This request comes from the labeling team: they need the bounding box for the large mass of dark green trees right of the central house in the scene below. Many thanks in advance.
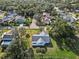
[49,17,79,54]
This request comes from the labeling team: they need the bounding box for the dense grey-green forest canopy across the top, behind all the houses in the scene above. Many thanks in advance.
[0,0,78,17]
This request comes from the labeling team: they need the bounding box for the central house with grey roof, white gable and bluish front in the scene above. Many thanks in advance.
[32,33,50,46]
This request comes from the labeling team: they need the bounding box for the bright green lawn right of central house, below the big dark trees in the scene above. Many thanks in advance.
[46,40,76,59]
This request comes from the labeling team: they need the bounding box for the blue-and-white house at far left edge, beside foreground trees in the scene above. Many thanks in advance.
[1,33,13,48]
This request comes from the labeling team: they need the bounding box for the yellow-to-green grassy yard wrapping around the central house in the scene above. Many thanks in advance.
[26,29,77,59]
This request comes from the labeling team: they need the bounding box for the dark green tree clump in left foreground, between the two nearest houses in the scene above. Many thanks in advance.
[4,29,33,59]
